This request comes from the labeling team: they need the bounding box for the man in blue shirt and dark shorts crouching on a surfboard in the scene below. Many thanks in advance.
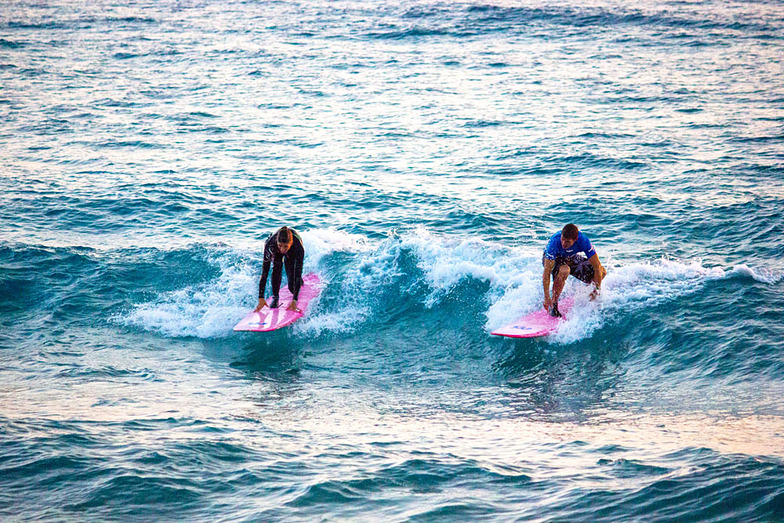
[542,223,607,317]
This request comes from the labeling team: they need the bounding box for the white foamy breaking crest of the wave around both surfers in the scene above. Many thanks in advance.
[114,228,782,343]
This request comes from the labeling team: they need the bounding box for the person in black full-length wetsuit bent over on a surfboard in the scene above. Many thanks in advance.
[255,227,305,312]
